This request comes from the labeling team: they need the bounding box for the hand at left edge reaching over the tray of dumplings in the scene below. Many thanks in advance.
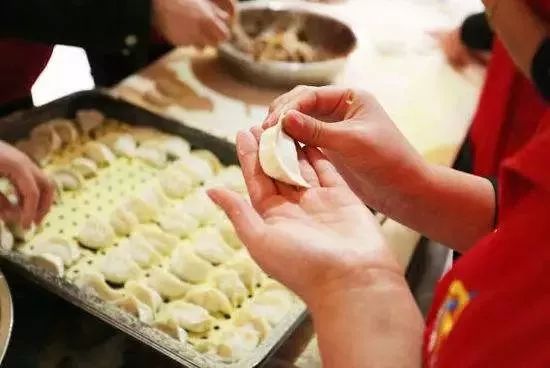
[0,142,54,229]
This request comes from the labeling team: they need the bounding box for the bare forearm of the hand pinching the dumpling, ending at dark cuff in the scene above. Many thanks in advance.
[380,165,496,252]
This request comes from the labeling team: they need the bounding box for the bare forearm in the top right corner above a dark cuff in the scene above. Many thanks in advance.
[483,0,548,78]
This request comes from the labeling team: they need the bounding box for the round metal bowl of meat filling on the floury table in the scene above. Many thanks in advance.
[219,2,357,87]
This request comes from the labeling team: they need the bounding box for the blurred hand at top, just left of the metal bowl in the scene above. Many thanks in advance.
[153,0,235,47]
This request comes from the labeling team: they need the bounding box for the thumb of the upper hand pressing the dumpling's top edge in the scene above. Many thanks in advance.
[283,110,350,151]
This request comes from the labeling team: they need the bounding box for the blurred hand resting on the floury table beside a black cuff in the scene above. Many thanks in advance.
[432,28,490,70]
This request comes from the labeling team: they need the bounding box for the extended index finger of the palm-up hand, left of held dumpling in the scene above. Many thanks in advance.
[237,131,277,208]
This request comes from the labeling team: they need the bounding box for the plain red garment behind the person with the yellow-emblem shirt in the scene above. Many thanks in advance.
[470,0,550,176]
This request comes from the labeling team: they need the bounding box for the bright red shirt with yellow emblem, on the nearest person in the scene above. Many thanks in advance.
[424,110,550,368]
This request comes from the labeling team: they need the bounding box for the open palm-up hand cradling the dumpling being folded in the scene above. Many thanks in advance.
[209,132,401,303]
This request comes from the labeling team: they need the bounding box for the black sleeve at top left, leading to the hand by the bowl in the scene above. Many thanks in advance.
[0,0,151,63]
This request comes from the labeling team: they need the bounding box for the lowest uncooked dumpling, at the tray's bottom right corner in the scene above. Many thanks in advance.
[217,325,260,359]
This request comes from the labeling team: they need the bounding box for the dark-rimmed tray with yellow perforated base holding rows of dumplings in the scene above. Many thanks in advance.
[0,91,305,367]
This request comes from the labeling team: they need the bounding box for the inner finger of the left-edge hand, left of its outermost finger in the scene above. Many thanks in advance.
[9,169,40,229]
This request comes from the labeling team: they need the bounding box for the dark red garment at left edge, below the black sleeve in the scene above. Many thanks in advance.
[0,39,52,105]
